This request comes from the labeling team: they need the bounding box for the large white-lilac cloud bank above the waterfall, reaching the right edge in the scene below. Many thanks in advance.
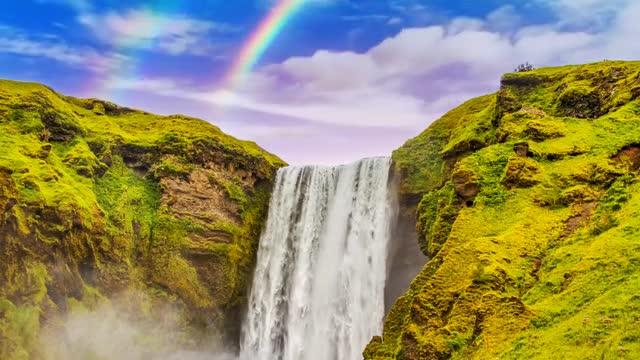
[95,4,640,162]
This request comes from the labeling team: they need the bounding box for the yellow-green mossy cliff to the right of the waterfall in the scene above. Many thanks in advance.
[364,62,640,359]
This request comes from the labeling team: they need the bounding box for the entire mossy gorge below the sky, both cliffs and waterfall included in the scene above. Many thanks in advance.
[0,61,640,360]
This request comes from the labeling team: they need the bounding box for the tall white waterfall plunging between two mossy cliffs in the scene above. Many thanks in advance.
[240,158,394,360]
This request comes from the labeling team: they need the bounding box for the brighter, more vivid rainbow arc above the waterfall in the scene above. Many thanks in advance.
[222,0,305,90]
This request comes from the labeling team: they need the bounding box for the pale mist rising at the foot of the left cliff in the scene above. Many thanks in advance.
[41,304,237,360]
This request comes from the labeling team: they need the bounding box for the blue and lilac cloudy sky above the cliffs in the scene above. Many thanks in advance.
[0,0,640,164]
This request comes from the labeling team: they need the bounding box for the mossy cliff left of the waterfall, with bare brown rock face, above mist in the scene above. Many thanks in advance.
[0,80,284,359]
